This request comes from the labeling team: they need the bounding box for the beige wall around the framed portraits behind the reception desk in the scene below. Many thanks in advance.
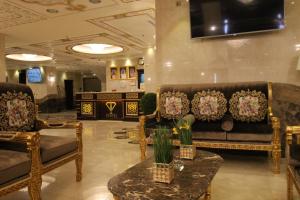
[106,59,142,92]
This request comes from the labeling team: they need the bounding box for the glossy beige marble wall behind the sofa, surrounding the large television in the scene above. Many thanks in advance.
[152,0,300,90]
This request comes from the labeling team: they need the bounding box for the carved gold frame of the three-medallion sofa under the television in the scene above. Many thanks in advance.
[139,83,281,174]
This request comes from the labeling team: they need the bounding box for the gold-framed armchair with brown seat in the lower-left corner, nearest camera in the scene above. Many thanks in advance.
[0,131,42,200]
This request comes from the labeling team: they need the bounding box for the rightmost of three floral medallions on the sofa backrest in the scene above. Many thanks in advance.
[229,90,268,122]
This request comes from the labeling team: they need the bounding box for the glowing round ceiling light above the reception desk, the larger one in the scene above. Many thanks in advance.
[72,43,124,54]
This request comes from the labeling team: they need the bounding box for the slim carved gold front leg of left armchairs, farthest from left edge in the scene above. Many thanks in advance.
[75,123,83,182]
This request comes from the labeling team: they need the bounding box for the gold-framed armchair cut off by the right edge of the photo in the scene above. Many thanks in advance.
[286,126,300,200]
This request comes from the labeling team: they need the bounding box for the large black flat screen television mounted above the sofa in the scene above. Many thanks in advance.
[189,0,285,38]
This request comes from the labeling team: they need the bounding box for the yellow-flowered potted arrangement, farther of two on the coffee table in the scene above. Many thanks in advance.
[173,114,196,159]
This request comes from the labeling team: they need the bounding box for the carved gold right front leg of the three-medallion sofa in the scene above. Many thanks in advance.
[272,117,281,174]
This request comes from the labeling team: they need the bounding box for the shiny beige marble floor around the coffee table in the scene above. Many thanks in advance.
[1,121,299,200]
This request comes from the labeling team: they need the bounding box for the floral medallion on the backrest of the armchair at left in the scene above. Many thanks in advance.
[0,92,35,131]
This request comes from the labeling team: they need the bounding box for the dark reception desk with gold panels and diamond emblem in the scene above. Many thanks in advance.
[76,92,144,121]
